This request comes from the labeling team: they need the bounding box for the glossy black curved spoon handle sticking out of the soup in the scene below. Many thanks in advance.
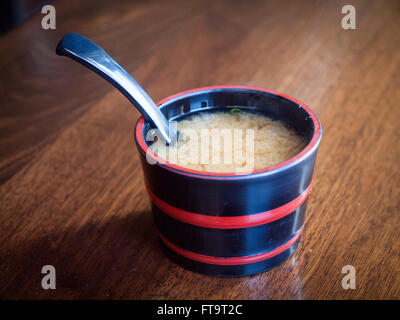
[56,33,176,143]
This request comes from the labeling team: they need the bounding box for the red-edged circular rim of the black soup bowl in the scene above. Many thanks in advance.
[135,85,322,180]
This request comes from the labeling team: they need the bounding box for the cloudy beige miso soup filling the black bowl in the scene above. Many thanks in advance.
[150,108,306,173]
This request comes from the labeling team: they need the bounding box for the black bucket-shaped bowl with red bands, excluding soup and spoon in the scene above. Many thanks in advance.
[135,86,321,276]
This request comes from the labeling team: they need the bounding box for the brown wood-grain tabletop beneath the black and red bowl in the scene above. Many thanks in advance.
[0,0,400,299]
